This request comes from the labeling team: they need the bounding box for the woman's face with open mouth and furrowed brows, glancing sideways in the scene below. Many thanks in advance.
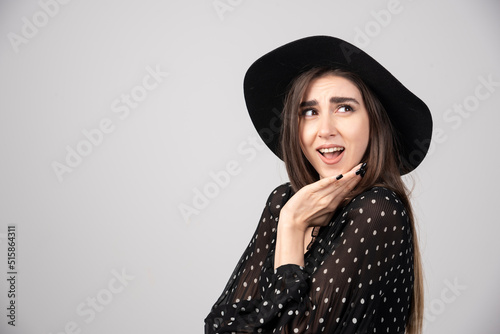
[299,75,370,178]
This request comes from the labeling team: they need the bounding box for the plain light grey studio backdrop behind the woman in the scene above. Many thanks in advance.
[0,0,500,334]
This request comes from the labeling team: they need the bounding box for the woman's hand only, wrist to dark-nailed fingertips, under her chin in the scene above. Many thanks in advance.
[280,164,361,232]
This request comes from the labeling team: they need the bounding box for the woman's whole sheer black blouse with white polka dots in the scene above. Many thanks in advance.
[205,183,413,334]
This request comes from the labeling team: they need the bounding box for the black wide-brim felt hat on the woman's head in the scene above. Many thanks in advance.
[243,36,432,173]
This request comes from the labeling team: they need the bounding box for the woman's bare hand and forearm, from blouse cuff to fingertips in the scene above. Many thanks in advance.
[274,164,364,269]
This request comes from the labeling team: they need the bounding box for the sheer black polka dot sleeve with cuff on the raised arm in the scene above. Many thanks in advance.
[205,184,309,333]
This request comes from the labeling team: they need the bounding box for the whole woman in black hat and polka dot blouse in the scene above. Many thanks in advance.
[205,36,432,334]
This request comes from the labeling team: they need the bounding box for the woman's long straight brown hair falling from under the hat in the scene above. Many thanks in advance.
[281,67,424,334]
